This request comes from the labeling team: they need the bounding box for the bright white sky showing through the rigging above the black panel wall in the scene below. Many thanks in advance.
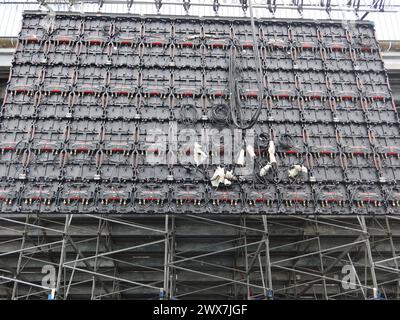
[0,0,400,41]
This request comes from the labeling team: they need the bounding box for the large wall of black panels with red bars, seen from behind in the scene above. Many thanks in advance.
[0,13,400,214]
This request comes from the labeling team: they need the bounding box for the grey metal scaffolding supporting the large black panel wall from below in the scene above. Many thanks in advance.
[0,214,400,300]
